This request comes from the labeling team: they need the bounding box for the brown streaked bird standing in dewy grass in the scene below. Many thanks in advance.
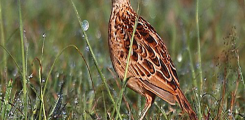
[108,0,197,120]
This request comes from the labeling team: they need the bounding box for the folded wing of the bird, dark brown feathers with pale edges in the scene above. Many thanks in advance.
[124,17,179,104]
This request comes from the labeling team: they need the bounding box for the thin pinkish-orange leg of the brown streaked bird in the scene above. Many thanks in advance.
[139,92,156,120]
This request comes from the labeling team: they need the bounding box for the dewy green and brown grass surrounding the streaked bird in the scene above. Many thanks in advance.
[0,0,245,120]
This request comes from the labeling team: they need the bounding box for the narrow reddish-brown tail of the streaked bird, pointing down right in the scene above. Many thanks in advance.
[176,89,198,120]
